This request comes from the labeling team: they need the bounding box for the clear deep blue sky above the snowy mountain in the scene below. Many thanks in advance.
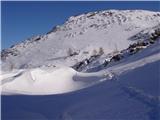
[1,1,159,49]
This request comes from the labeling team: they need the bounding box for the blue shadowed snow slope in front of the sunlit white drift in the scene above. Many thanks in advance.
[2,36,160,120]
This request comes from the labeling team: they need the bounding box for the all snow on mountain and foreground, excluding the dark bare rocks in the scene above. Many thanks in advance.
[0,10,160,120]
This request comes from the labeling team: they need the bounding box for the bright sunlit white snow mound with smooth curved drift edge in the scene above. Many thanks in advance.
[1,67,108,95]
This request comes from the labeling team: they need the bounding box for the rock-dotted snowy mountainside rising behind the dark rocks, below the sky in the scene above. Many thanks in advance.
[1,10,160,70]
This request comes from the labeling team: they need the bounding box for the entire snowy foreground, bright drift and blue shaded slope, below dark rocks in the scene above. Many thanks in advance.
[1,41,160,120]
